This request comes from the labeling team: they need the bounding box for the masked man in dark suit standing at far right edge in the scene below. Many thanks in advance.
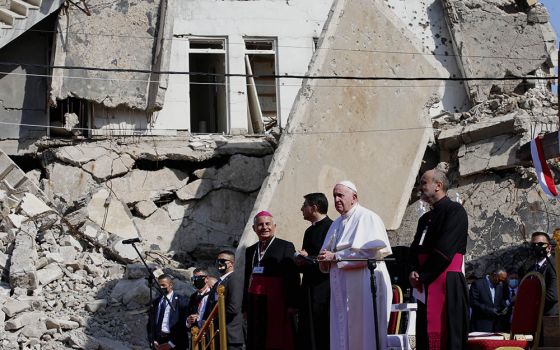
[528,232,558,316]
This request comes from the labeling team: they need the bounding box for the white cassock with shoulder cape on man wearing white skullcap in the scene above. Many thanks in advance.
[322,204,392,350]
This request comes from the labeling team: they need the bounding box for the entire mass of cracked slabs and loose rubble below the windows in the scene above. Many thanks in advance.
[0,136,274,349]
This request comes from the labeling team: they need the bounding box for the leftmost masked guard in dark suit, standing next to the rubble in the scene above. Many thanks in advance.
[148,274,187,350]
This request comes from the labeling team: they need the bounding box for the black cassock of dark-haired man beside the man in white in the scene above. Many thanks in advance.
[297,216,332,350]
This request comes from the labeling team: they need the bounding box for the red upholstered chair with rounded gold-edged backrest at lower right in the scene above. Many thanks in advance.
[468,272,545,350]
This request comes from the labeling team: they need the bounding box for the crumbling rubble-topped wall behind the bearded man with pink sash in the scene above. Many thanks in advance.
[389,89,560,277]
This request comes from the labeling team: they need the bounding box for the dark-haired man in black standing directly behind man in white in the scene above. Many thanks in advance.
[294,193,332,350]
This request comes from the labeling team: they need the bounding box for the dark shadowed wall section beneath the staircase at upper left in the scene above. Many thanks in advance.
[0,14,56,154]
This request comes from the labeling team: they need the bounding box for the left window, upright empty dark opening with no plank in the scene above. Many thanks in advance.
[186,35,231,134]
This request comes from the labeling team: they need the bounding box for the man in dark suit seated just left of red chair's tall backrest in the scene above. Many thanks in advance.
[469,269,507,332]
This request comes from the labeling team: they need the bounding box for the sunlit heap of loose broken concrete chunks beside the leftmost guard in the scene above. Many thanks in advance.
[0,190,199,350]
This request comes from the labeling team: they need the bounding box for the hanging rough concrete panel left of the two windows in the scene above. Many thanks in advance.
[50,0,168,111]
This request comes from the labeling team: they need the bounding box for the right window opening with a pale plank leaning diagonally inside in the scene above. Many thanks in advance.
[243,36,281,133]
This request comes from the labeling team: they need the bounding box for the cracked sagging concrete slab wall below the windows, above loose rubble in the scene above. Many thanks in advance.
[37,136,274,262]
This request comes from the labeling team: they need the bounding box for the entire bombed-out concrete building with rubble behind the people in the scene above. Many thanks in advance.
[0,0,560,349]
